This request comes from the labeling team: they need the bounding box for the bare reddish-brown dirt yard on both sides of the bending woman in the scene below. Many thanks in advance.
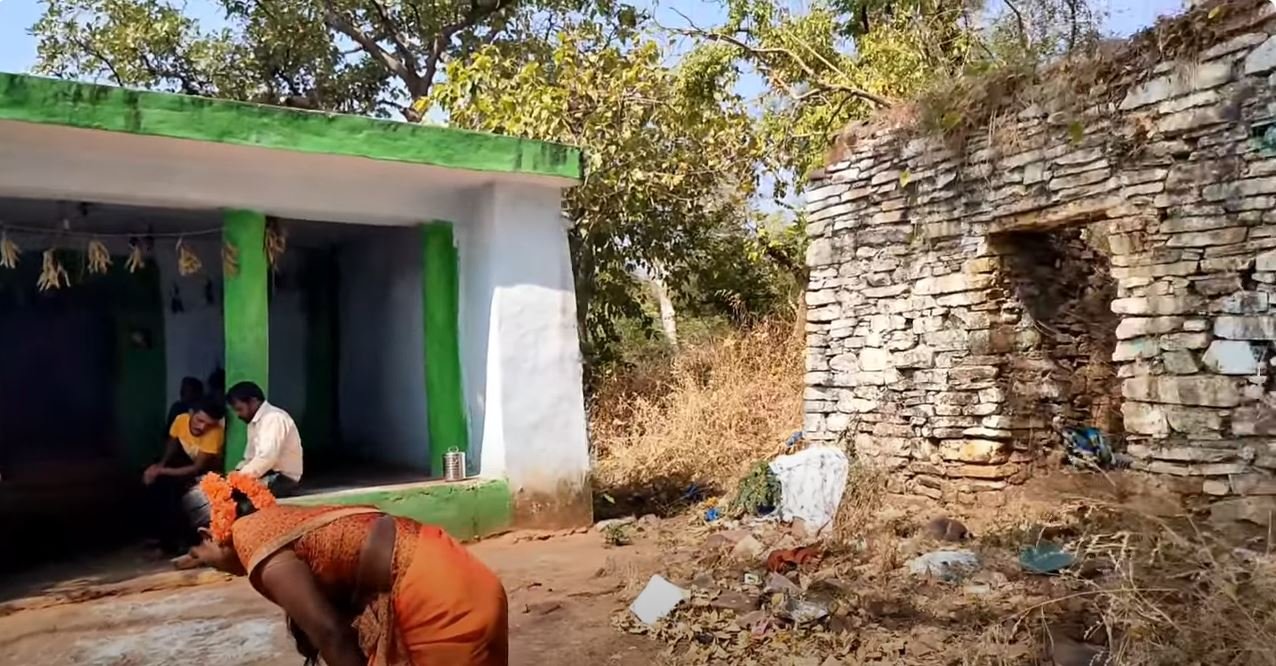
[0,532,662,666]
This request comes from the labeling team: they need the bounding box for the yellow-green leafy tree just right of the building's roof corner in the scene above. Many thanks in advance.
[430,17,760,359]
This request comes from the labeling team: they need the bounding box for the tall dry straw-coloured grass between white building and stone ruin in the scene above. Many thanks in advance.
[590,315,804,495]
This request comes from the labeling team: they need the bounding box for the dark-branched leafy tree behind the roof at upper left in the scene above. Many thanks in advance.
[31,0,584,120]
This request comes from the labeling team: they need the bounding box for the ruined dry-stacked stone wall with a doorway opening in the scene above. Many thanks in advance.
[805,3,1276,505]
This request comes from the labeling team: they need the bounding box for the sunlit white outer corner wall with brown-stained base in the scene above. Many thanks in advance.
[459,185,592,524]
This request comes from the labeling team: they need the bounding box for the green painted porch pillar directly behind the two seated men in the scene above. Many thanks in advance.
[222,211,271,471]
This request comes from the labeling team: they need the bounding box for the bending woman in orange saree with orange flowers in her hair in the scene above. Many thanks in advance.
[188,473,509,666]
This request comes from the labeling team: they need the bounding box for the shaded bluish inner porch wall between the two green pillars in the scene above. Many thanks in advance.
[338,227,429,471]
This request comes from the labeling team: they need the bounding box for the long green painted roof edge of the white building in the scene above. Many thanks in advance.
[0,73,583,180]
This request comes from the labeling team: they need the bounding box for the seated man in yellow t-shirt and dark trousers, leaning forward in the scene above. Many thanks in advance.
[142,399,226,554]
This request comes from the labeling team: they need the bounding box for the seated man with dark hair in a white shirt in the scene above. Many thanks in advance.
[226,381,301,496]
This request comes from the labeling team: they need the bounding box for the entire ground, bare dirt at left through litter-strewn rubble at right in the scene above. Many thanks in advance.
[0,473,1276,666]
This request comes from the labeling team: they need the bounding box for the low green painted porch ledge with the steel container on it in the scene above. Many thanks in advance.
[283,478,514,541]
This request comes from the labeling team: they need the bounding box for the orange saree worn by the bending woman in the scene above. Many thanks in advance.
[232,505,509,666]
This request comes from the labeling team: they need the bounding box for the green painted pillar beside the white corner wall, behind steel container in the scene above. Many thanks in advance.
[421,222,470,476]
